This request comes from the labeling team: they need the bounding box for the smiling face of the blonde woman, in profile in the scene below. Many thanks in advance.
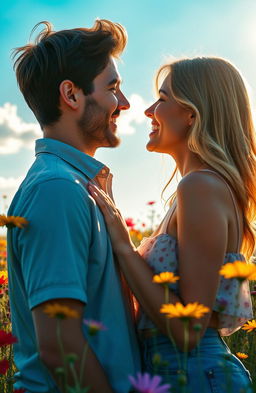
[145,76,193,154]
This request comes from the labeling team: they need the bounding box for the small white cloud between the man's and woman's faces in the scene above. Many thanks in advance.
[117,94,149,134]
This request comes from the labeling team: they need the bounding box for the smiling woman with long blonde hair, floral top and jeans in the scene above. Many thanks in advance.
[90,58,256,393]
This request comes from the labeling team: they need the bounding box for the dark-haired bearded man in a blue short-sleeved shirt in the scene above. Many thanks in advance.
[8,20,140,393]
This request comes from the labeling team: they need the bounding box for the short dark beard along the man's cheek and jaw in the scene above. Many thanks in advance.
[77,97,120,147]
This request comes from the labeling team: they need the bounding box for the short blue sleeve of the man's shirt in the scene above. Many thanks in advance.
[18,179,91,309]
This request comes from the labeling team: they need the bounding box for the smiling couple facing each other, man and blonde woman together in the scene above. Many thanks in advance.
[8,20,256,393]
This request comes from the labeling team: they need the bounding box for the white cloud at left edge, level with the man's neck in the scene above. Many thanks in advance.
[0,102,42,154]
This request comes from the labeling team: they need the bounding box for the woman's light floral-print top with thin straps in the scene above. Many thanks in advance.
[138,170,253,336]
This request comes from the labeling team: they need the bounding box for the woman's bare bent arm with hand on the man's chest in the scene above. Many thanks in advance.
[91,173,227,349]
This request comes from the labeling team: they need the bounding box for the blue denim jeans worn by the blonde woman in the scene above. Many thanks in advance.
[141,328,252,393]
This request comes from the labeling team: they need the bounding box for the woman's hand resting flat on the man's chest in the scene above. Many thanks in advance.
[88,183,135,255]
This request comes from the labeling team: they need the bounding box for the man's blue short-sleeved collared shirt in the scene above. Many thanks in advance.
[7,138,140,393]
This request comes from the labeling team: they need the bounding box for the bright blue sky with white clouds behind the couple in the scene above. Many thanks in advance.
[0,0,256,230]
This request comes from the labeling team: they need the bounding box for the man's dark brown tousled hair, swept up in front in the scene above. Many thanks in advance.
[13,19,127,127]
